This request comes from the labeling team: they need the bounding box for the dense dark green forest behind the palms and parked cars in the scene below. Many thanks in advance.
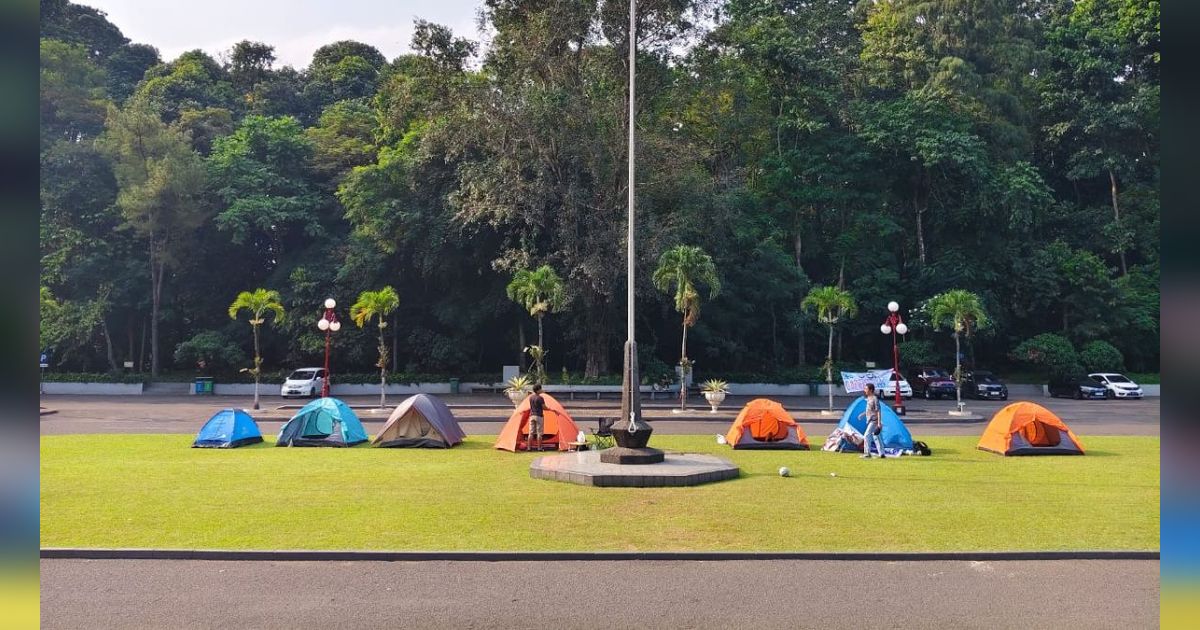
[41,0,1159,379]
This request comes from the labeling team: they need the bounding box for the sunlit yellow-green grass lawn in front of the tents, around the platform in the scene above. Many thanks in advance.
[41,428,1159,551]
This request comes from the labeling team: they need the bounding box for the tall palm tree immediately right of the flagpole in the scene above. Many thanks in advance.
[652,245,721,409]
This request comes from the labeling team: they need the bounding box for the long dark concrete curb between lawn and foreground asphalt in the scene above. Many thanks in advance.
[41,547,1159,562]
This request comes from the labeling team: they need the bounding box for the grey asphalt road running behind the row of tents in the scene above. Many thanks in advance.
[41,395,1159,436]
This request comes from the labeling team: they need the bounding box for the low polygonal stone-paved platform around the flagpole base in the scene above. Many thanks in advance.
[529,451,738,487]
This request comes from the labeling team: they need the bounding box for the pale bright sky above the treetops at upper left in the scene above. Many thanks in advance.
[78,0,482,68]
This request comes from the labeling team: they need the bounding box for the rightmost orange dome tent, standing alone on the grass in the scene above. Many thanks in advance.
[979,402,1084,455]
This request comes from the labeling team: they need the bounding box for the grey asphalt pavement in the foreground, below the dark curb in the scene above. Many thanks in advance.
[41,560,1159,630]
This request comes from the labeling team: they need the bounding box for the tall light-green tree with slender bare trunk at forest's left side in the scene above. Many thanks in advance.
[98,102,209,377]
